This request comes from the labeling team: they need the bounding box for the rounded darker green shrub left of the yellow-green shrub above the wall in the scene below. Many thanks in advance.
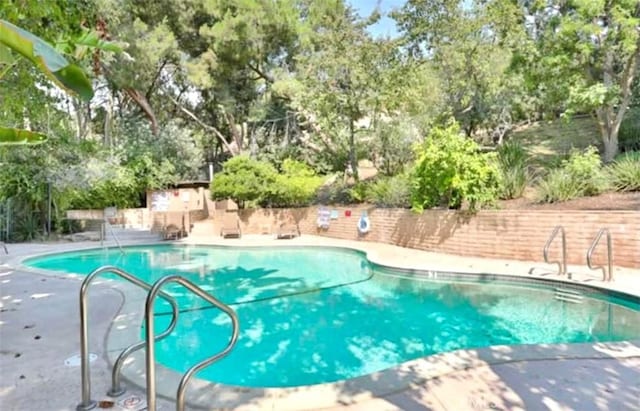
[211,156,278,208]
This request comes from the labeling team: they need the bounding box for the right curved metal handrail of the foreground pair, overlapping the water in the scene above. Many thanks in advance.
[145,275,239,411]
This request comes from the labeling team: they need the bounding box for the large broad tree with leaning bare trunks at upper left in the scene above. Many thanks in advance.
[110,0,299,161]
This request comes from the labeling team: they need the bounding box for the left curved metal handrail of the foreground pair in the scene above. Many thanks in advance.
[76,266,178,411]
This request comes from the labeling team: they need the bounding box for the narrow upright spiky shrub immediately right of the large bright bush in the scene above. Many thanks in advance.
[498,141,530,199]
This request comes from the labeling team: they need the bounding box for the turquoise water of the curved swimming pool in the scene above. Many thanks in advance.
[25,245,640,387]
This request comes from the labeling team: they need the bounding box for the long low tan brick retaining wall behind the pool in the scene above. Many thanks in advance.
[238,206,640,268]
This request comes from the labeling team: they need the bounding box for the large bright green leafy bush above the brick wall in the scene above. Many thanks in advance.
[411,123,499,211]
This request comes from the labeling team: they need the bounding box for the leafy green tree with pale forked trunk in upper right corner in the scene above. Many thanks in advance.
[519,0,640,162]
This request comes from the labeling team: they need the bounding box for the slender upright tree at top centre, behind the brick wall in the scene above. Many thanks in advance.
[274,0,396,179]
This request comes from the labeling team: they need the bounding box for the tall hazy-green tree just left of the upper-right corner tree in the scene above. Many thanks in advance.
[394,0,524,137]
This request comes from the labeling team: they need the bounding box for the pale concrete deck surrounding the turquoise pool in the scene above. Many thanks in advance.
[0,236,640,411]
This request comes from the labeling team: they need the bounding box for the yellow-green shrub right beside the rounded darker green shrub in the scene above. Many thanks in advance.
[263,159,322,207]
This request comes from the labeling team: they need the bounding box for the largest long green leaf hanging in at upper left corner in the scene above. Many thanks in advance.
[0,20,93,100]
